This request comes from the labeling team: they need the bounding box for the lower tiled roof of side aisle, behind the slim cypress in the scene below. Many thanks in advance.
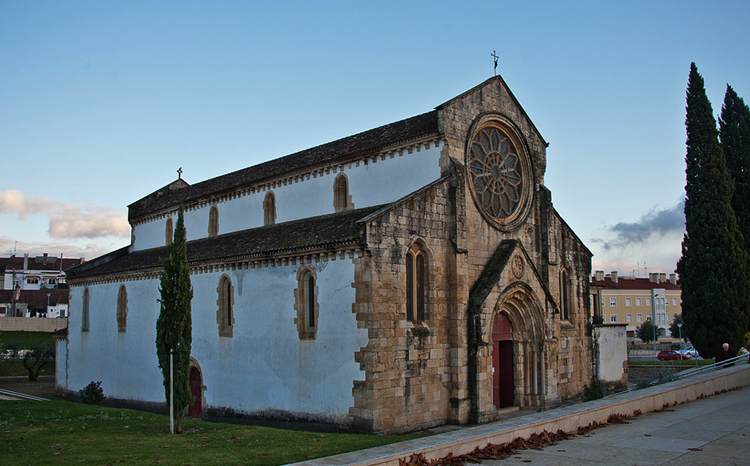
[67,206,382,280]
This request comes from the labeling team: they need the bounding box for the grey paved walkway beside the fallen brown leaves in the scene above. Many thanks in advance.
[482,387,750,466]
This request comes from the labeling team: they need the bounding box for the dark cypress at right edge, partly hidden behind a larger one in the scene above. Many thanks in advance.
[719,85,750,251]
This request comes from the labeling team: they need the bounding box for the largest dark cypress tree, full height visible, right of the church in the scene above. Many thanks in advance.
[677,63,748,357]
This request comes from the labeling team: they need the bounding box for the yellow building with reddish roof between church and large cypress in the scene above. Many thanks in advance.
[590,270,682,338]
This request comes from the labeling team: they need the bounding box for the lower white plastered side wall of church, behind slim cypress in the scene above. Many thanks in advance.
[68,259,367,422]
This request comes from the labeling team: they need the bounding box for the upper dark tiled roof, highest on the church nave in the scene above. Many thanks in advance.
[128,110,439,221]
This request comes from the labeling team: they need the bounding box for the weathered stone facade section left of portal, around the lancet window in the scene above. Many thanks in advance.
[350,180,455,432]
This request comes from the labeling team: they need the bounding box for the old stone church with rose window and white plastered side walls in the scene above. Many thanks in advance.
[63,76,592,433]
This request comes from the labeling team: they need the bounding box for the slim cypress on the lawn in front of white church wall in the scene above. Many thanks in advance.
[156,204,193,432]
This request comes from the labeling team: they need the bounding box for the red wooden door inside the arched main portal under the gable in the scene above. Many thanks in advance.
[492,314,515,409]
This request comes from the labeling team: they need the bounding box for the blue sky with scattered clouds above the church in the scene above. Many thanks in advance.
[0,0,750,276]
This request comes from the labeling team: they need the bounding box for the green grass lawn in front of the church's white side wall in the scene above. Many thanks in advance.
[0,401,417,466]
